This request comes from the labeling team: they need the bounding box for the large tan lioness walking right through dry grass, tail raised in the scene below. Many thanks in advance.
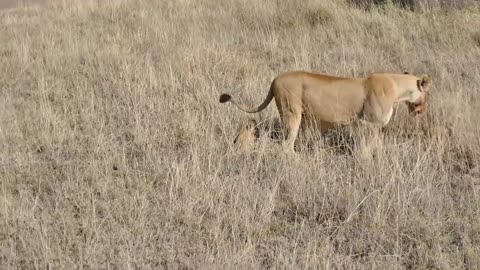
[220,71,432,151]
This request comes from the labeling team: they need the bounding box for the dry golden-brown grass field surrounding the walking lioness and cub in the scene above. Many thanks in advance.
[0,0,480,269]
